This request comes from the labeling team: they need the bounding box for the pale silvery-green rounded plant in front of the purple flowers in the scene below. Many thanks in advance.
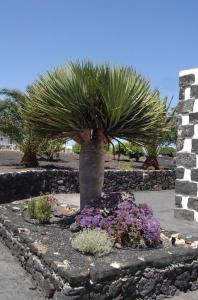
[71,229,113,256]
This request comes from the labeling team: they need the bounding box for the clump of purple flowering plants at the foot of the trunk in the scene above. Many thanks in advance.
[76,193,160,249]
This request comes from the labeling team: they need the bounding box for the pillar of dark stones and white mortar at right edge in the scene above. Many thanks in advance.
[175,68,198,222]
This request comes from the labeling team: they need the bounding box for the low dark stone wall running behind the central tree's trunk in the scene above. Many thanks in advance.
[0,169,175,203]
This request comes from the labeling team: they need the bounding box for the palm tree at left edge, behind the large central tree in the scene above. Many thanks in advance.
[0,89,39,167]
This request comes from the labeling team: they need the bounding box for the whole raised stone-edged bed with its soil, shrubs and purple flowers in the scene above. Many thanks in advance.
[0,193,198,300]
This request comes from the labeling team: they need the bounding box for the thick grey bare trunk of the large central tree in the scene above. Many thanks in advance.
[79,140,104,209]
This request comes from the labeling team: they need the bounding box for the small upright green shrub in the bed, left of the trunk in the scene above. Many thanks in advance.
[28,196,51,224]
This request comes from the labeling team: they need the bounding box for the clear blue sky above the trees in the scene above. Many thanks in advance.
[0,0,198,105]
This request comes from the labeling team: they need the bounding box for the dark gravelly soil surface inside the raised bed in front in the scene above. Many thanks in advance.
[0,200,175,268]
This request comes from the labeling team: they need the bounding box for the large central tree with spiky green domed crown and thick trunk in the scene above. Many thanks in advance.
[24,62,170,209]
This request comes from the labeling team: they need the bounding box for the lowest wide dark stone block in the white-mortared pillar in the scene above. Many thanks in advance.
[175,180,197,196]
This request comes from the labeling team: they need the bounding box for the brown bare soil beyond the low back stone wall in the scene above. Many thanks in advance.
[0,150,175,173]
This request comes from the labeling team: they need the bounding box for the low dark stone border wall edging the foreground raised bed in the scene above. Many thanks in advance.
[0,204,198,300]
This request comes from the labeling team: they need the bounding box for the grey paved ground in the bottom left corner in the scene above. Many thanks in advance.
[0,241,44,300]
